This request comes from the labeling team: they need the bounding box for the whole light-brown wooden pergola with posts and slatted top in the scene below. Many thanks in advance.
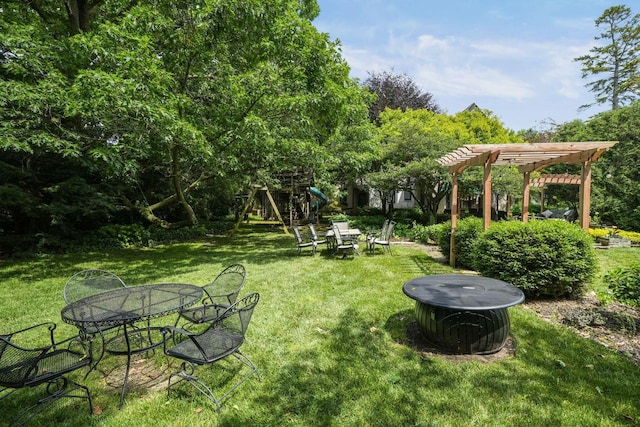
[438,141,617,266]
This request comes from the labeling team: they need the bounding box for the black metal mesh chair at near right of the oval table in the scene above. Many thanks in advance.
[163,292,260,410]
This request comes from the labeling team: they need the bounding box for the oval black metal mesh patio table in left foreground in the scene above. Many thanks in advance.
[61,283,204,407]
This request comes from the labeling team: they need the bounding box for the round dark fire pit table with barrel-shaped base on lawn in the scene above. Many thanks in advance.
[402,274,524,354]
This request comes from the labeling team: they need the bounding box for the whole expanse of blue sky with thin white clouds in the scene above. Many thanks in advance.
[314,0,624,130]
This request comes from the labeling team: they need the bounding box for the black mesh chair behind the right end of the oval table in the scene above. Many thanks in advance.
[176,264,247,327]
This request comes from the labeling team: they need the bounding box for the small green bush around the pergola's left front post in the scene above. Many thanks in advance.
[438,216,484,269]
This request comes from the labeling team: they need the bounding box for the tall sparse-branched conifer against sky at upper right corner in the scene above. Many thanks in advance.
[574,6,640,110]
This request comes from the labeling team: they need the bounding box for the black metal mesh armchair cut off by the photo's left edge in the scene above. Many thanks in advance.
[0,322,93,425]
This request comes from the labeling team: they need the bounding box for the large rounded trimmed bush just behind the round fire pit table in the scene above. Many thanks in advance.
[474,221,596,298]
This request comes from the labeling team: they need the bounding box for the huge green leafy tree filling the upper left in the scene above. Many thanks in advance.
[0,0,370,234]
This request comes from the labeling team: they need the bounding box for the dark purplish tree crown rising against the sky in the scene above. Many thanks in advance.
[364,71,441,125]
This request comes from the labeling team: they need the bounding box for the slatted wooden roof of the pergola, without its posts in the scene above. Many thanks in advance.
[438,141,617,173]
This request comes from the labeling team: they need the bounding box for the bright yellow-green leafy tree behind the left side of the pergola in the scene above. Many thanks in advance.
[367,109,521,221]
